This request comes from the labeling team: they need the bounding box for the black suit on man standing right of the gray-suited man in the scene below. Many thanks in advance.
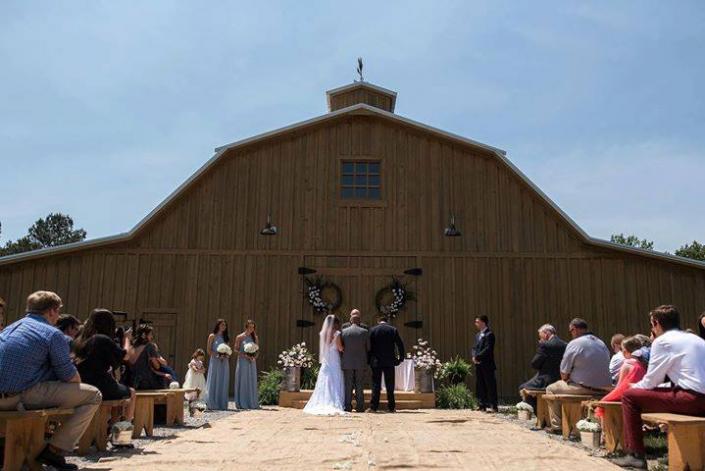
[369,322,404,411]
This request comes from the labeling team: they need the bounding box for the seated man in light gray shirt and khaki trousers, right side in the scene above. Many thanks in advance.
[546,318,612,433]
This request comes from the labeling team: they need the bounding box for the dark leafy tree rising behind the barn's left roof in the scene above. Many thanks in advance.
[0,213,86,256]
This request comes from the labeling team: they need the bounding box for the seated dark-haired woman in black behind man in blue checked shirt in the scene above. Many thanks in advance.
[74,309,135,421]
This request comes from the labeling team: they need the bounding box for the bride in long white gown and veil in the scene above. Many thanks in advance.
[304,314,345,415]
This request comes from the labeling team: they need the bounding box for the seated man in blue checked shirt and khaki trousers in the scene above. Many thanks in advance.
[0,291,101,470]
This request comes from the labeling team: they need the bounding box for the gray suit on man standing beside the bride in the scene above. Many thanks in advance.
[341,324,370,412]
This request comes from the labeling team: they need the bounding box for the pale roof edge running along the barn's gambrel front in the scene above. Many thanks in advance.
[0,100,705,269]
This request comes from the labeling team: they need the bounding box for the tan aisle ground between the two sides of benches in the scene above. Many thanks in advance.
[87,408,619,471]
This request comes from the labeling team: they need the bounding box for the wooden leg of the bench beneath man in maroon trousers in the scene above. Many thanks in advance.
[668,423,705,471]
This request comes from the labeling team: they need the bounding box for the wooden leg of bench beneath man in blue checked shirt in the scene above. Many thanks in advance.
[3,417,47,471]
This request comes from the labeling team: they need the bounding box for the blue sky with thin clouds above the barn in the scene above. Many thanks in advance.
[0,0,705,251]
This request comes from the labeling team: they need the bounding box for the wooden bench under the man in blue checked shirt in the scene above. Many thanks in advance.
[0,409,73,471]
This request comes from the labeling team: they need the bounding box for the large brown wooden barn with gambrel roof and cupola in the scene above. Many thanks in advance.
[0,82,705,396]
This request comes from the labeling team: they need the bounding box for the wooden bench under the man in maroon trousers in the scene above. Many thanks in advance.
[641,412,705,471]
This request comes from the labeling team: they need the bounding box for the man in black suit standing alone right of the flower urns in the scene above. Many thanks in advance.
[472,315,498,412]
